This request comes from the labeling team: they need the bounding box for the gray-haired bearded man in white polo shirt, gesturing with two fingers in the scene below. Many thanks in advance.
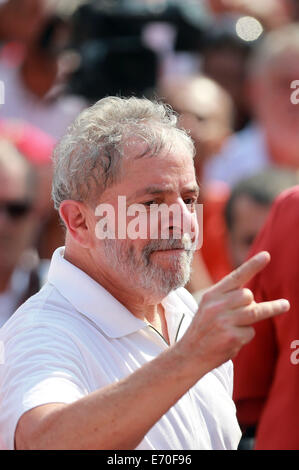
[0,97,289,450]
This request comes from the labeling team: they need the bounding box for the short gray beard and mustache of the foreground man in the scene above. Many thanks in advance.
[104,239,194,297]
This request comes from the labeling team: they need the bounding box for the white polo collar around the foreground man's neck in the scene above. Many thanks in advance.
[48,247,191,338]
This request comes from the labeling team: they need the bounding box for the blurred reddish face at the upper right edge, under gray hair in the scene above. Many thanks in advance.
[251,51,299,168]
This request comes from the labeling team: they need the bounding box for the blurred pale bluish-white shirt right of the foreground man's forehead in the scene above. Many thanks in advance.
[203,125,270,186]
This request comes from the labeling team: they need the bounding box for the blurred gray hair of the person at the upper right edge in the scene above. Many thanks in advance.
[248,23,299,76]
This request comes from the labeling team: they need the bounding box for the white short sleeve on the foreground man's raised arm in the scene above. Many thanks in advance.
[0,326,89,450]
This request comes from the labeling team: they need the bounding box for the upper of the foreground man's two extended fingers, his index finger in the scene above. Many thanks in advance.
[209,251,270,293]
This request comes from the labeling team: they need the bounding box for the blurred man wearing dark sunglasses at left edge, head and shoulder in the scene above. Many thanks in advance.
[0,138,40,326]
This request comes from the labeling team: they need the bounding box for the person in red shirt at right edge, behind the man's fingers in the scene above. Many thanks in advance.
[234,186,299,450]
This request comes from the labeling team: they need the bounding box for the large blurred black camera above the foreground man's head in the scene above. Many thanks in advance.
[69,0,206,101]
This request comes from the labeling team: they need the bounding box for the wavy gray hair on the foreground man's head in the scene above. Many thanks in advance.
[52,97,194,209]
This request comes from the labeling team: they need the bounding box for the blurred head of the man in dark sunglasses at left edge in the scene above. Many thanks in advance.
[0,141,36,272]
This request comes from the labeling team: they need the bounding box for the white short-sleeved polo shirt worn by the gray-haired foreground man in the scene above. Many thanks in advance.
[0,247,241,450]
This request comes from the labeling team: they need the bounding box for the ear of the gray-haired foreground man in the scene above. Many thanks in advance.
[59,199,91,248]
